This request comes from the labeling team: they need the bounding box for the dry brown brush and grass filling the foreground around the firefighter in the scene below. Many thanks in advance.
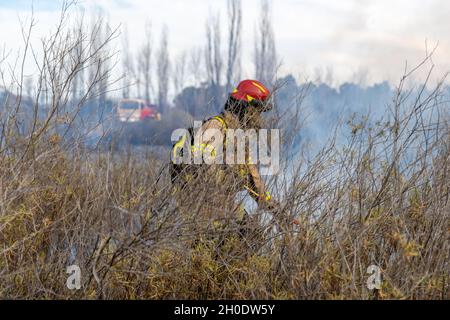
[0,2,450,299]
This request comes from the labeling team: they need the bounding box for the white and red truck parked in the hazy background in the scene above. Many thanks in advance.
[117,99,161,122]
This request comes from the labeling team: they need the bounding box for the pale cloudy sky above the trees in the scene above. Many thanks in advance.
[0,0,450,86]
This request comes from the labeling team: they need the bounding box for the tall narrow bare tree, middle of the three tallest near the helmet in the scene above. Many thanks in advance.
[225,0,242,93]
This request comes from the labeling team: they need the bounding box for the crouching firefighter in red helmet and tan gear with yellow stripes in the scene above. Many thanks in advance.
[172,80,277,242]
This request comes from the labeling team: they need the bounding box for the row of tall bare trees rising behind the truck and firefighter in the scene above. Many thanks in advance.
[122,0,278,113]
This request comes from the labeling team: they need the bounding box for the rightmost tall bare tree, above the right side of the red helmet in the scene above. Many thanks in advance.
[254,0,278,85]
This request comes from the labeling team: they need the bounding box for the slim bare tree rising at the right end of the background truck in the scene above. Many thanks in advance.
[156,26,170,112]
